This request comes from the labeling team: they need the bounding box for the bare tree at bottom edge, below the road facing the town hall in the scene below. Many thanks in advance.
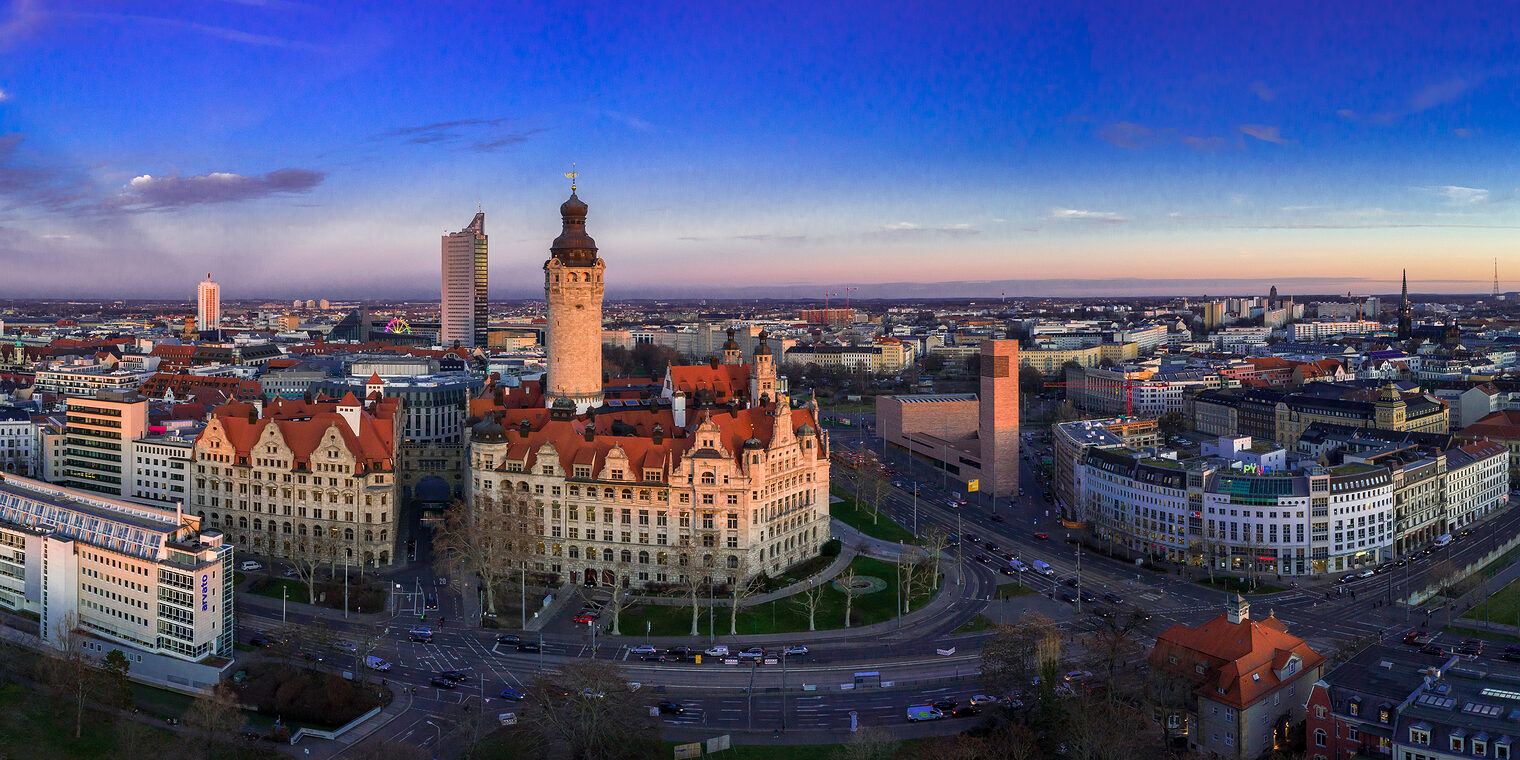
[518,660,660,760]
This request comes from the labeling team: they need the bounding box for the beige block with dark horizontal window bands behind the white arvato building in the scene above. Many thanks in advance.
[62,389,147,497]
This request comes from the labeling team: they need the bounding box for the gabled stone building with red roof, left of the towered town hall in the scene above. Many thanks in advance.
[185,394,400,567]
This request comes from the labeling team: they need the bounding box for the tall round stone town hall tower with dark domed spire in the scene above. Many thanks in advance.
[544,172,606,412]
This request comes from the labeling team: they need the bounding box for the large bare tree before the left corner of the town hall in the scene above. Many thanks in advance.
[433,483,543,616]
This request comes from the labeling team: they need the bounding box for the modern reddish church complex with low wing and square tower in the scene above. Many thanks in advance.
[876,340,1020,497]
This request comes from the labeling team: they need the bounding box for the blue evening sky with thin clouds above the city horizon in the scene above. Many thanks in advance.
[0,0,1520,298]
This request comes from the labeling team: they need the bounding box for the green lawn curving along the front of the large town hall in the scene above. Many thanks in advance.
[617,556,932,637]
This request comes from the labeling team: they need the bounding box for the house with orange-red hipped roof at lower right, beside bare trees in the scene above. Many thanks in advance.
[1149,596,1325,760]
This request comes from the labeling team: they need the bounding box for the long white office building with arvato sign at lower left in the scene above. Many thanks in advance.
[0,476,236,689]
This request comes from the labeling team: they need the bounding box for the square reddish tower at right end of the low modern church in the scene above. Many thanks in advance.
[976,340,1018,499]
